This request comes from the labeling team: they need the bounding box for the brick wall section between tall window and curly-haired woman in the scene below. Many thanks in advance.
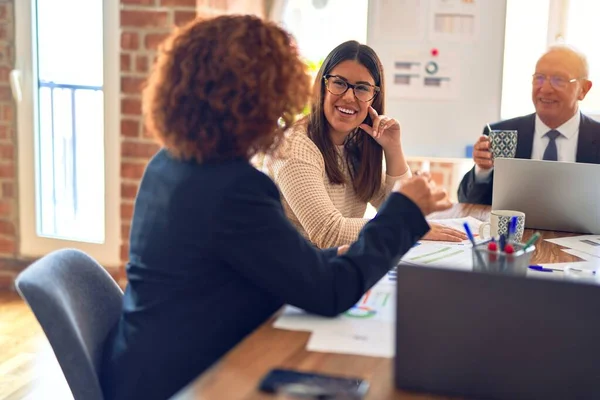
[120,0,263,278]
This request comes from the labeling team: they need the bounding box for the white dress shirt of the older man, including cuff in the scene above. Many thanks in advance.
[475,110,581,183]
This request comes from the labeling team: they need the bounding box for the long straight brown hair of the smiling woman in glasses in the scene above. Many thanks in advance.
[307,40,385,202]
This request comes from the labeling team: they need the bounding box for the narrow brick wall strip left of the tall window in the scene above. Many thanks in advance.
[0,0,18,288]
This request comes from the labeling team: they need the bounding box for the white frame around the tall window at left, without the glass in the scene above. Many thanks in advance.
[11,0,121,267]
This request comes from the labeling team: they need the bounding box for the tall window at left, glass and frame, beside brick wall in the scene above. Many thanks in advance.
[13,0,120,266]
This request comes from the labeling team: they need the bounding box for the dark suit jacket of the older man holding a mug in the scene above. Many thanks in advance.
[458,114,600,205]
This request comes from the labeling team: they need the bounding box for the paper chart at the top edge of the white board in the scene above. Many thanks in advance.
[428,0,481,43]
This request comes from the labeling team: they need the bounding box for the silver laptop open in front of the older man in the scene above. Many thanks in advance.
[492,158,600,234]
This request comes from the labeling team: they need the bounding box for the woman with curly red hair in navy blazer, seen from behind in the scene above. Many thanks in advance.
[101,15,449,400]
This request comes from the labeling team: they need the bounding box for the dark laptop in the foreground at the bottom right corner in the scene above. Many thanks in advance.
[394,264,600,400]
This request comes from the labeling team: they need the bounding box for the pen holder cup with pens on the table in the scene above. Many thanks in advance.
[472,240,535,276]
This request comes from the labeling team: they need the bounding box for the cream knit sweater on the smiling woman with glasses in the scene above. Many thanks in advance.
[262,124,411,248]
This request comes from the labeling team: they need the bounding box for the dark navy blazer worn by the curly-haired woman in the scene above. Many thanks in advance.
[101,150,429,400]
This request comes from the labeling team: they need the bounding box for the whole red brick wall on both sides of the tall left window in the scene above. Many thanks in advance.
[0,0,272,289]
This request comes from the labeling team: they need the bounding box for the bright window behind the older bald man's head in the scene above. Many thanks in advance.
[501,0,600,119]
